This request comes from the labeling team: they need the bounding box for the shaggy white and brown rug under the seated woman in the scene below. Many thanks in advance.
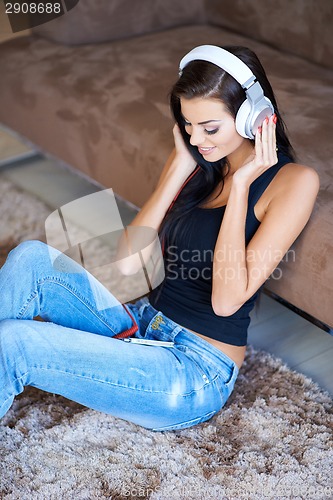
[0,180,333,500]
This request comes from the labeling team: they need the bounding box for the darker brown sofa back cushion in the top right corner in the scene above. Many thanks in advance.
[205,0,333,68]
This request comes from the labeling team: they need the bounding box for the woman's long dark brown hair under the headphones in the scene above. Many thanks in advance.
[160,46,295,244]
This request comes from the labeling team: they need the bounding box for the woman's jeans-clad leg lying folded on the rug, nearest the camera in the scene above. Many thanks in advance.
[0,320,222,430]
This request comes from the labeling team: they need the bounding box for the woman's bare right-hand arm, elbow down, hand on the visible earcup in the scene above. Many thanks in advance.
[212,115,319,316]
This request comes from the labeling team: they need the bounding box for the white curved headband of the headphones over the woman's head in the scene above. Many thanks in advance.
[179,45,256,90]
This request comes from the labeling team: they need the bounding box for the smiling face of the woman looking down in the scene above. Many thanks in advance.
[180,97,249,162]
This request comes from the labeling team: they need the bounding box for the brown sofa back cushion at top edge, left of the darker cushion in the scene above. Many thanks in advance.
[32,0,205,45]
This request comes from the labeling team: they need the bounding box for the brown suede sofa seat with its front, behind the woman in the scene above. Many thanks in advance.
[0,25,333,327]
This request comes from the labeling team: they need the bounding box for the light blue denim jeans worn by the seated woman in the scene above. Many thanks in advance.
[0,241,238,431]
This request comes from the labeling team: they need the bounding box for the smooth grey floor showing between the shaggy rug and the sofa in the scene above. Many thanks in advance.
[0,130,333,395]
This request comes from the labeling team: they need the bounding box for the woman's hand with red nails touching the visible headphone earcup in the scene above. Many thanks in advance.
[233,114,278,186]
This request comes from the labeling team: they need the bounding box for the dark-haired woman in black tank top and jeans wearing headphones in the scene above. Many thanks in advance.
[0,46,319,430]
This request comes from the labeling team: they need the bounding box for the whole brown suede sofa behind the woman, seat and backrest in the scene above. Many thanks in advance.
[0,0,333,327]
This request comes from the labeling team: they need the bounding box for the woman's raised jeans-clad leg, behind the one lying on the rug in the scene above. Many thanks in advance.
[0,241,132,336]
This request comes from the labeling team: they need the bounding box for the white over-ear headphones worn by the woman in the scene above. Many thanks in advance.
[179,45,274,139]
